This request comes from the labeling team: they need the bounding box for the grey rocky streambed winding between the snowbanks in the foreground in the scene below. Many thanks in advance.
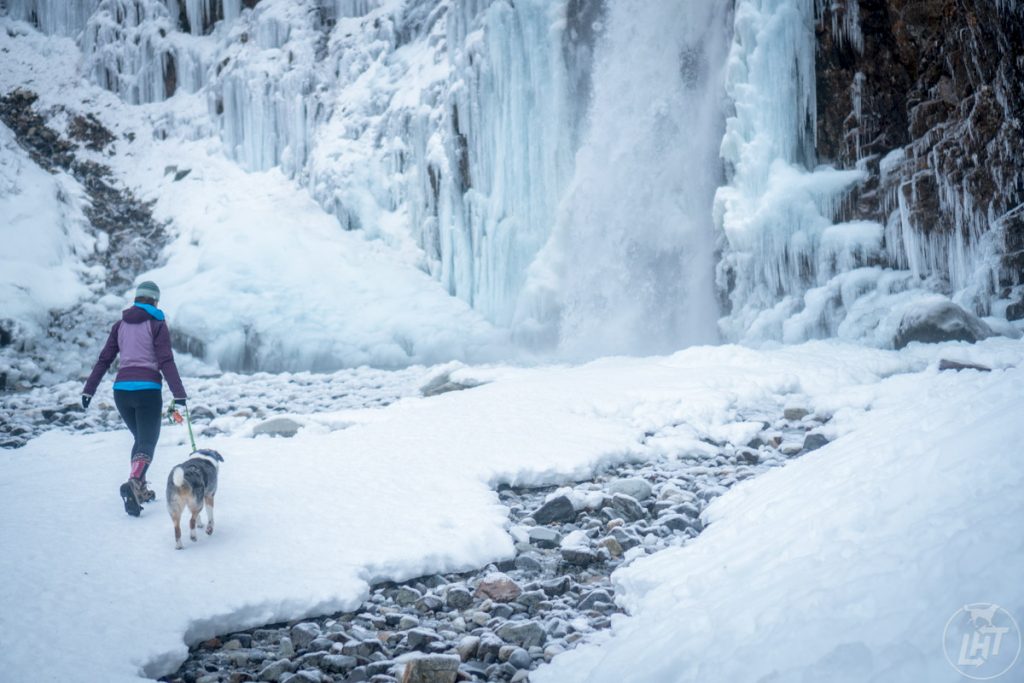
[161,408,827,683]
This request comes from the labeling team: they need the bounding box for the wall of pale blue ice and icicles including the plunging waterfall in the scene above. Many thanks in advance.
[6,0,1017,368]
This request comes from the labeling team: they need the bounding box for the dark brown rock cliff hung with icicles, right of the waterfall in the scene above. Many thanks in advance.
[816,0,1024,319]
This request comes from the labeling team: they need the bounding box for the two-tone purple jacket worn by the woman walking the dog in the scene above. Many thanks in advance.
[82,306,187,398]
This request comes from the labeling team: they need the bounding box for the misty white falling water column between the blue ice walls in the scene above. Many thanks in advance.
[517,0,731,356]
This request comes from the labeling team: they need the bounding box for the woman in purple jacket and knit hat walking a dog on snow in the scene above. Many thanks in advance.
[82,281,186,517]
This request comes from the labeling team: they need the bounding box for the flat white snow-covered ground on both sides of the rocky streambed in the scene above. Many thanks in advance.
[0,339,1024,681]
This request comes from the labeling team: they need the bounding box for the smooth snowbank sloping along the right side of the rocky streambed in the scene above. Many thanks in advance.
[531,342,1024,683]
